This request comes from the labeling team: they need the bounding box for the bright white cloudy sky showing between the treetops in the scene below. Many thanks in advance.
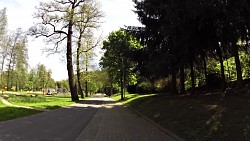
[0,0,141,80]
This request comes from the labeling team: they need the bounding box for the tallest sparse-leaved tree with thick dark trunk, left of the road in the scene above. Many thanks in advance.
[30,0,92,101]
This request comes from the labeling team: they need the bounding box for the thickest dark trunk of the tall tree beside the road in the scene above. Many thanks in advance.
[66,4,79,101]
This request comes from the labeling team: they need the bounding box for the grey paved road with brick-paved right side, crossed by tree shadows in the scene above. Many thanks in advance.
[0,95,182,141]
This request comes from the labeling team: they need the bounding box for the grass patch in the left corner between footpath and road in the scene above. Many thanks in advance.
[0,101,41,121]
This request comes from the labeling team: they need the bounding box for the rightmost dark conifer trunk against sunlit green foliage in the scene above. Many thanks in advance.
[232,44,242,86]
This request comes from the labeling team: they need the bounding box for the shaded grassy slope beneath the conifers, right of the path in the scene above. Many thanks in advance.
[114,94,250,141]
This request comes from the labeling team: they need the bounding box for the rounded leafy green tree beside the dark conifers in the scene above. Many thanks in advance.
[101,30,141,100]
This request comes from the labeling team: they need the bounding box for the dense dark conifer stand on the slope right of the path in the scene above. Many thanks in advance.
[103,0,250,95]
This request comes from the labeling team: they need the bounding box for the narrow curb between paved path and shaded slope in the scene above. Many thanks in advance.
[119,102,185,141]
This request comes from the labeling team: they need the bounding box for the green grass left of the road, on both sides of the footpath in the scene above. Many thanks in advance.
[0,94,83,121]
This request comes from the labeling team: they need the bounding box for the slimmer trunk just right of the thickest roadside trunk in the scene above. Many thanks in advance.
[76,34,84,98]
